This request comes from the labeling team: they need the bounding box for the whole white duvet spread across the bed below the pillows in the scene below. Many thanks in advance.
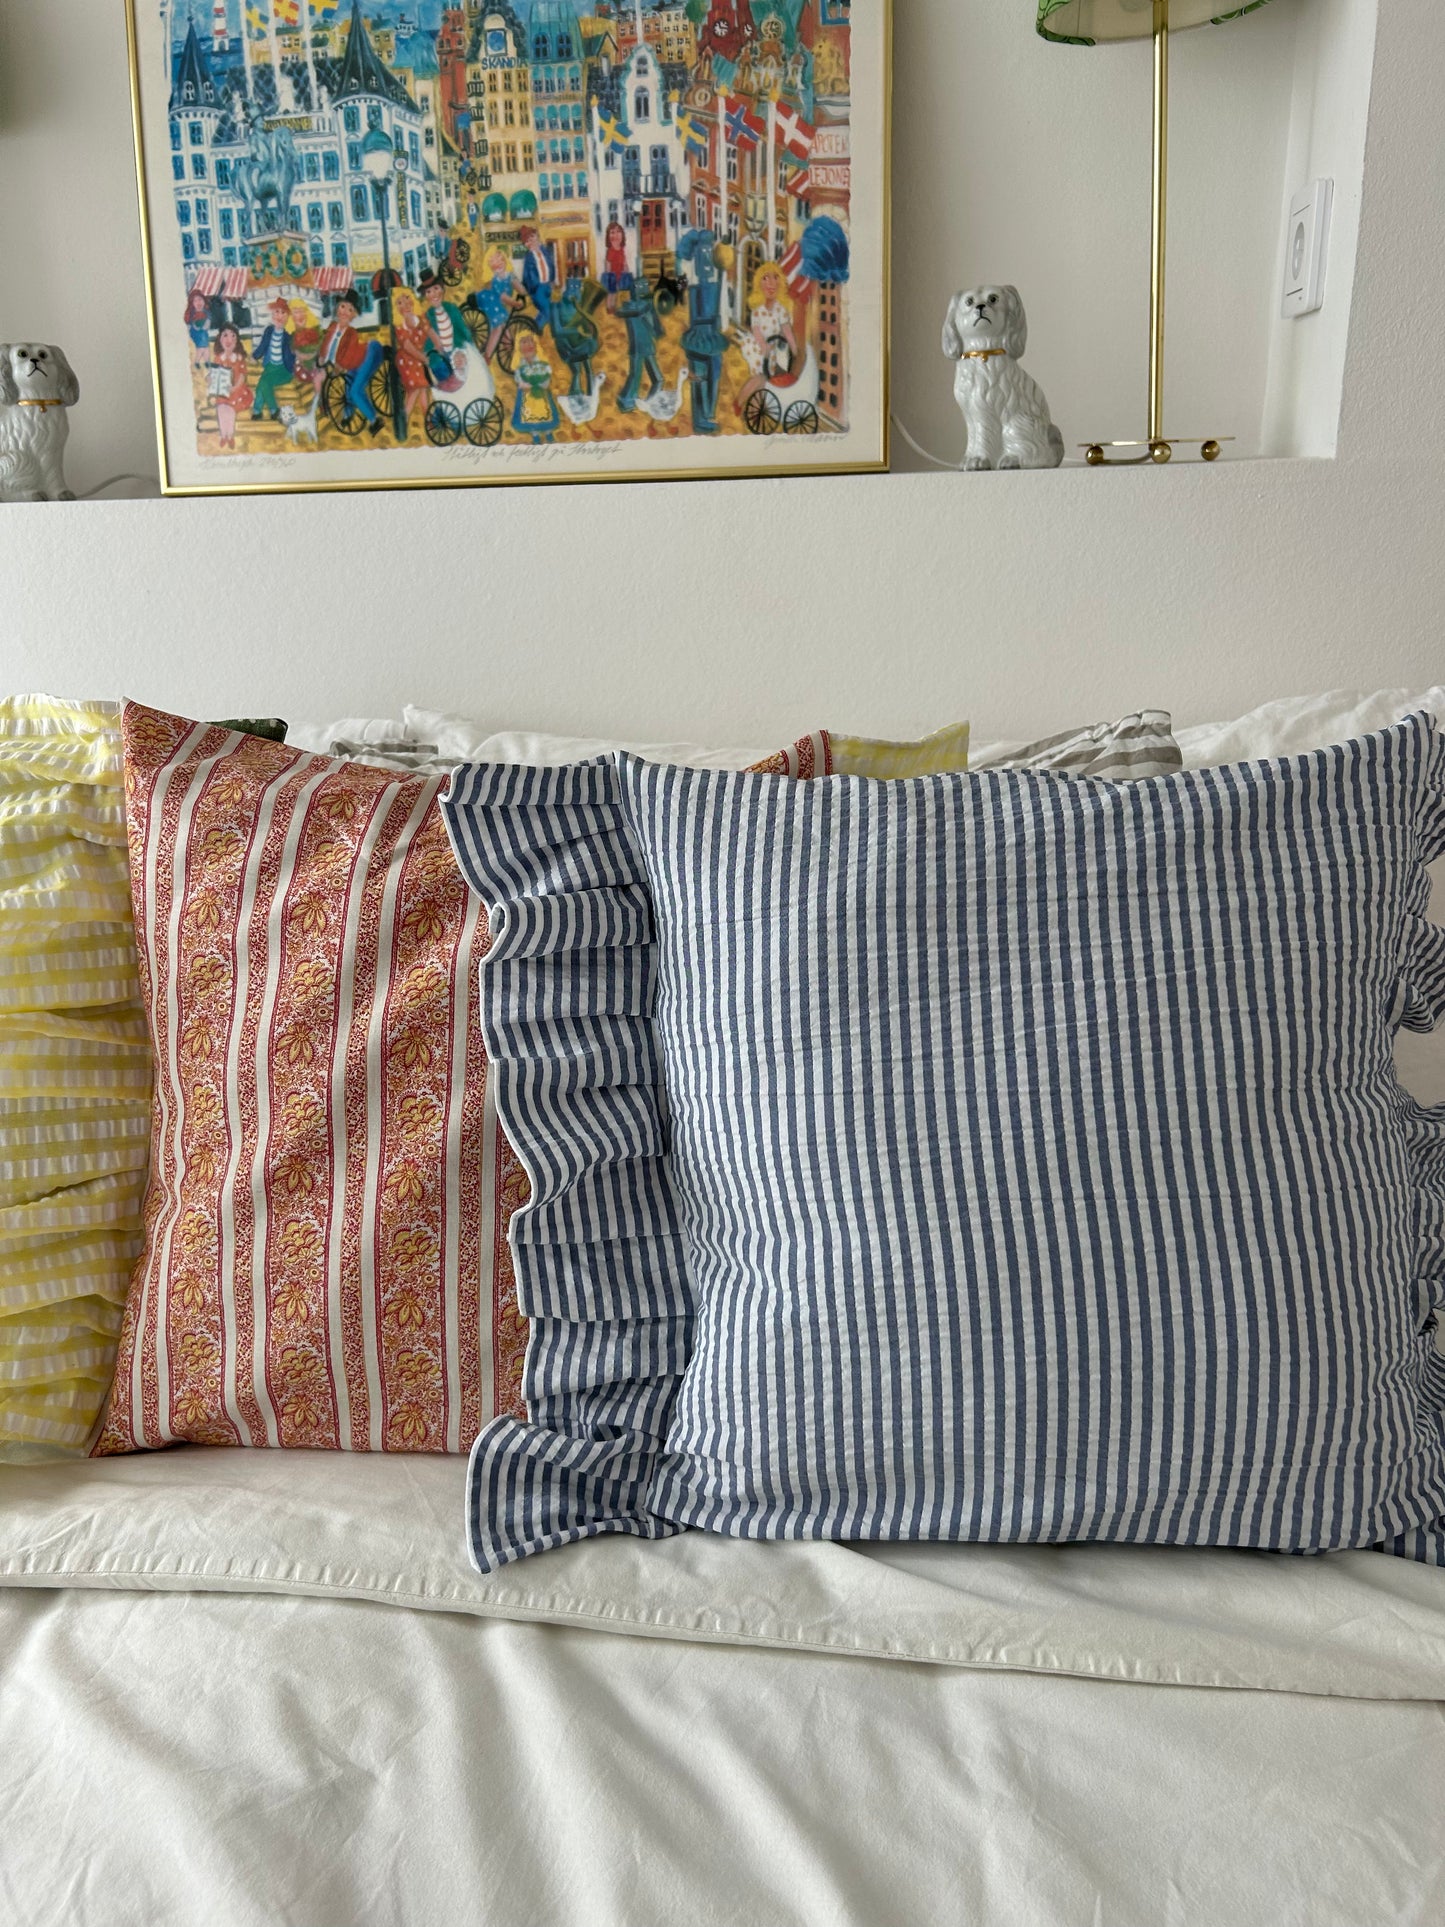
[0,1449,1445,1927]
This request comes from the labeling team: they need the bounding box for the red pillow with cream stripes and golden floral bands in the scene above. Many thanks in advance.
[94,705,526,1455]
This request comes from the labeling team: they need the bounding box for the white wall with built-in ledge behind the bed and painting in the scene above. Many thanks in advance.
[0,0,1445,740]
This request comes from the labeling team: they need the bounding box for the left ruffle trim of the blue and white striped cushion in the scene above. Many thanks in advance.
[443,759,694,1572]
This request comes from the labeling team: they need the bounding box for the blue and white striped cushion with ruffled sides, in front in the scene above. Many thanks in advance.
[449,719,1445,1569]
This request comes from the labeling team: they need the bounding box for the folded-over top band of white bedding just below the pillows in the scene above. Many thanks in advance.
[0,1449,1445,1700]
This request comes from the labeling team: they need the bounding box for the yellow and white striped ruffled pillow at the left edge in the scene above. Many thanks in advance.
[0,696,150,1459]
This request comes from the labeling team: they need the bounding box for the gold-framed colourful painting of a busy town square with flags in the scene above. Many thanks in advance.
[127,0,890,495]
